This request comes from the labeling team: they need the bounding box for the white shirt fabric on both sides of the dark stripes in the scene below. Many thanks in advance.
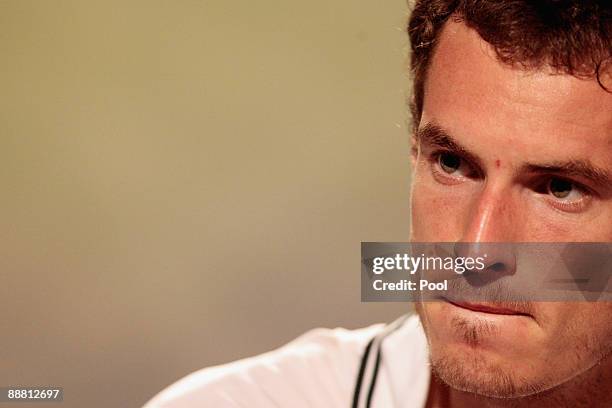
[144,316,430,408]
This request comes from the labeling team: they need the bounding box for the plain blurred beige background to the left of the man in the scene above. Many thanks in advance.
[0,0,409,408]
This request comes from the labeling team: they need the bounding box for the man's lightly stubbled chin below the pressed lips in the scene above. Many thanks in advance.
[417,302,557,398]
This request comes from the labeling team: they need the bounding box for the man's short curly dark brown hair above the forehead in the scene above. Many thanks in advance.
[408,0,612,129]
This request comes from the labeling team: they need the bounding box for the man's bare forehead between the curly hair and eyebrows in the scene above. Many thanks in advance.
[422,22,612,164]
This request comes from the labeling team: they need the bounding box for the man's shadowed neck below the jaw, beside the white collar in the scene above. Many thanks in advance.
[426,356,612,408]
